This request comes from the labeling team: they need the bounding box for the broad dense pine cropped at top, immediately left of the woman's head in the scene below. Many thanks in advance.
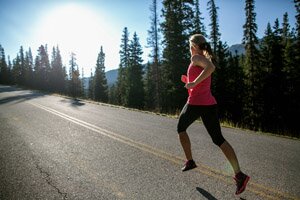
[161,0,193,112]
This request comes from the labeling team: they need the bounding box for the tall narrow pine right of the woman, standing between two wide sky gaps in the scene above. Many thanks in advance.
[243,0,263,130]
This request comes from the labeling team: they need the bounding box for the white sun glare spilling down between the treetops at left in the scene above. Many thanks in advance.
[34,4,116,72]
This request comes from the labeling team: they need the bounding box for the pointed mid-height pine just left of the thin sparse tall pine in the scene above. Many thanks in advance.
[125,32,144,109]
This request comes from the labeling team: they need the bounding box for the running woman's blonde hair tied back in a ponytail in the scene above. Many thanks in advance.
[189,34,214,61]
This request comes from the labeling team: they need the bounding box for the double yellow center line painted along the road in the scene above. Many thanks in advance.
[28,102,300,200]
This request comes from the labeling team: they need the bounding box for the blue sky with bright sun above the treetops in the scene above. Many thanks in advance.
[0,0,296,76]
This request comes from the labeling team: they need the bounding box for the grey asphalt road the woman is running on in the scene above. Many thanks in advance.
[0,85,300,200]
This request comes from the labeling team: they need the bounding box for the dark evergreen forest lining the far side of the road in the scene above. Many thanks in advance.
[0,0,300,138]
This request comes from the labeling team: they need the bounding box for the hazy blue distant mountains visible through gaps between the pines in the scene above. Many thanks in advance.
[83,44,245,89]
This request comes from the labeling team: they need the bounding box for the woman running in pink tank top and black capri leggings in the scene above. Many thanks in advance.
[177,34,250,195]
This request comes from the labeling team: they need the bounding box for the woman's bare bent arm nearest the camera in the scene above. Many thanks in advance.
[185,55,216,89]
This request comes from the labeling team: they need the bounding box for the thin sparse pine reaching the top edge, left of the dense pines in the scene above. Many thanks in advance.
[145,0,161,110]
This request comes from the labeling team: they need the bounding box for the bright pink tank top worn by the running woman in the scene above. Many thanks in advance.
[187,64,217,105]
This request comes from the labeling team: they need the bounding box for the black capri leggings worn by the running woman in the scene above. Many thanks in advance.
[177,104,225,146]
